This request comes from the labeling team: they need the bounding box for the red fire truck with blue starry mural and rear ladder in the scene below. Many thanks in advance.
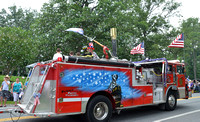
[15,56,188,122]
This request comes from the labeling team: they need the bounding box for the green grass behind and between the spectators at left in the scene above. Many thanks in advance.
[0,75,26,104]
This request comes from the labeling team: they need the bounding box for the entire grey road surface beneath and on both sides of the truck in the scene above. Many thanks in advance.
[0,93,200,122]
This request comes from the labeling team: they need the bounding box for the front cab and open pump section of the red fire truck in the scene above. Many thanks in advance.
[134,58,188,110]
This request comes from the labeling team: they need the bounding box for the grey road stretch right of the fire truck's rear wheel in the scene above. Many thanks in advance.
[111,93,200,122]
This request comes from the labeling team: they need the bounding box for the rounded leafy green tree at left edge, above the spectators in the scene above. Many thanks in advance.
[0,27,37,75]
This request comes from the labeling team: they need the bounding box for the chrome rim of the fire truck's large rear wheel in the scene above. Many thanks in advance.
[93,102,109,120]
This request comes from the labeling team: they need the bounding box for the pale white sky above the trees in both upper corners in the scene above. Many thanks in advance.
[0,0,200,27]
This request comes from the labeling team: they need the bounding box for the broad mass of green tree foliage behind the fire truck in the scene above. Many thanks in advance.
[0,0,195,78]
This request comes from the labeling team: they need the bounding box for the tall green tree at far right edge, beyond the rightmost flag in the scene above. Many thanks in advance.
[181,18,200,79]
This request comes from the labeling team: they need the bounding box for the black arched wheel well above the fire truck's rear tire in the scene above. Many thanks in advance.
[86,91,115,110]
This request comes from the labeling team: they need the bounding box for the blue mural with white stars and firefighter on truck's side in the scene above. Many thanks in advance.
[61,69,143,100]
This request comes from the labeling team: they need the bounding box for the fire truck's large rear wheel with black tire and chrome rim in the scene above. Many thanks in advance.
[85,95,112,122]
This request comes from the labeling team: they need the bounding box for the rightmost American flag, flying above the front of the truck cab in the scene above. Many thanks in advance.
[168,33,184,48]
